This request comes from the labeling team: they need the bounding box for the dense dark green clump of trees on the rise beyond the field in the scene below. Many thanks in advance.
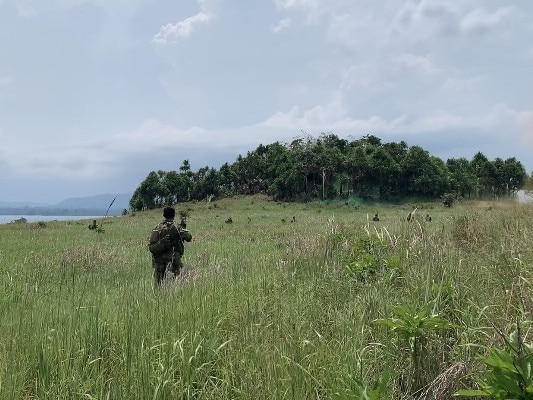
[130,134,528,211]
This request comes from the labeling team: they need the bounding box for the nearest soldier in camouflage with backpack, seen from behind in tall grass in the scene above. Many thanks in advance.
[149,207,192,286]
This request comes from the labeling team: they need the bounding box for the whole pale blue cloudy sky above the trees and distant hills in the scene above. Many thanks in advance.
[0,0,533,203]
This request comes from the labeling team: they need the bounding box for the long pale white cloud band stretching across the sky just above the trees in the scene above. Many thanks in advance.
[2,101,533,186]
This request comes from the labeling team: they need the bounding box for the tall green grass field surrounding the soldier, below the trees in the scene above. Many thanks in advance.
[0,197,533,400]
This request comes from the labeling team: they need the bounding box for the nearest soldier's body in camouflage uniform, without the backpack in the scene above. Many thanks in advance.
[152,207,192,286]
